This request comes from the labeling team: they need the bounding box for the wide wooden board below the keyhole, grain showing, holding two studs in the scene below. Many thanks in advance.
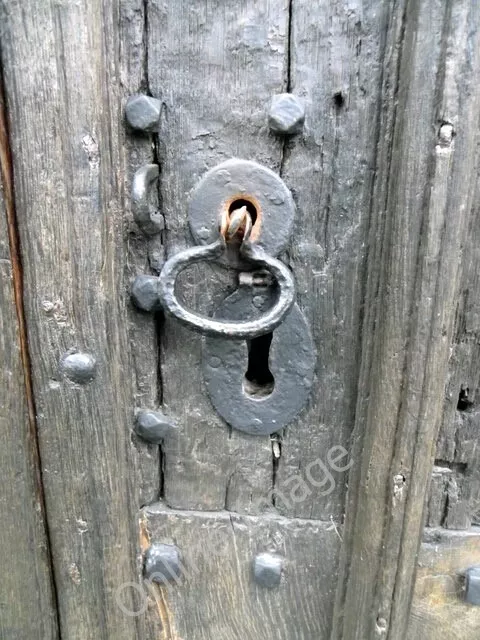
[144,504,340,640]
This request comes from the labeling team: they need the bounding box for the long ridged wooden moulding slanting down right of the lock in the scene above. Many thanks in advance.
[337,1,480,640]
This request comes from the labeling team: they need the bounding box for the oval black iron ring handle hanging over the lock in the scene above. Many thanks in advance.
[158,237,295,339]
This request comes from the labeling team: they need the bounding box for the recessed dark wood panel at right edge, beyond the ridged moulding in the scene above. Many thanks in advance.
[428,165,480,529]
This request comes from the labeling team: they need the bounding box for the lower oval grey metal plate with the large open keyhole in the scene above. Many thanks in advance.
[203,287,315,435]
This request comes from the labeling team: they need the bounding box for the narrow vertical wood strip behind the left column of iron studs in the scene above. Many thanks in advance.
[122,0,162,506]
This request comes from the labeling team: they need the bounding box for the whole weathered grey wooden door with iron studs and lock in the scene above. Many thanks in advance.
[0,0,480,640]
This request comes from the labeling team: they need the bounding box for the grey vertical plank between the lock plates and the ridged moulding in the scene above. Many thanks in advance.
[277,1,388,520]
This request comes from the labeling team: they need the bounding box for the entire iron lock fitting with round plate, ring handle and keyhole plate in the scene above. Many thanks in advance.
[150,159,315,435]
